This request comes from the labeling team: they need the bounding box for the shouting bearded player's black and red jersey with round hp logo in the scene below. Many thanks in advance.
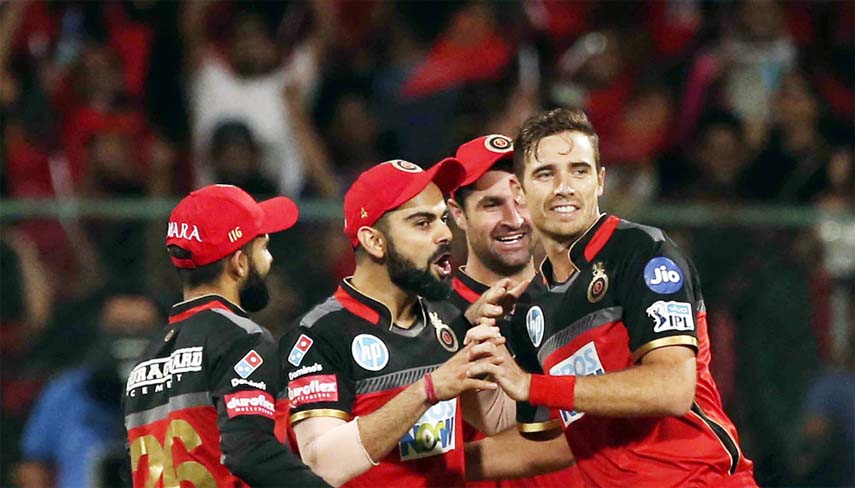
[279,279,466,488]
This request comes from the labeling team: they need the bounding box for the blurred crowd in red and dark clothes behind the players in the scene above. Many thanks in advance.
[0,0,855,486]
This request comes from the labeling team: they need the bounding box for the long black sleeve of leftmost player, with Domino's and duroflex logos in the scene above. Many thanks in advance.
[207,327,329,486]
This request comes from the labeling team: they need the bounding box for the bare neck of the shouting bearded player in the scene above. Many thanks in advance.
[350,266,418,329]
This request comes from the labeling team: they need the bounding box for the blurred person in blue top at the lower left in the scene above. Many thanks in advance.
[18,295,161,488]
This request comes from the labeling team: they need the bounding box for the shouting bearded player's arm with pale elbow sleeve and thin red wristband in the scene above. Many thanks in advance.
[291,347,498,486]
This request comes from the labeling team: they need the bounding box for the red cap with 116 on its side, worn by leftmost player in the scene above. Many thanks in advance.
[166,185,298,269]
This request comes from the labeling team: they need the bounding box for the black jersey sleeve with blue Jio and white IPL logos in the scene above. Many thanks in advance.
[616,234,700,361]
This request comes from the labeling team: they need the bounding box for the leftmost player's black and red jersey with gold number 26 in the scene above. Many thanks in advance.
[123,295,328,487]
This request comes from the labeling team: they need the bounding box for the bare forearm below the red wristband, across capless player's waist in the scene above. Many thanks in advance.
[465,428,575,481]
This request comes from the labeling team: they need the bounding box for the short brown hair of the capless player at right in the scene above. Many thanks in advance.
[514,108,600,181]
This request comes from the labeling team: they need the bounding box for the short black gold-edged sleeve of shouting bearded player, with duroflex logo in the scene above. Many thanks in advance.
[279,327,356,425]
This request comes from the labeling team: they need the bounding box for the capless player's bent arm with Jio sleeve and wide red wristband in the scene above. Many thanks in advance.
[497,241,705,417]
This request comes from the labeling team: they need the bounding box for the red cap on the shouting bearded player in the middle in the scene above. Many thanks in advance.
[344,158,466,247]
